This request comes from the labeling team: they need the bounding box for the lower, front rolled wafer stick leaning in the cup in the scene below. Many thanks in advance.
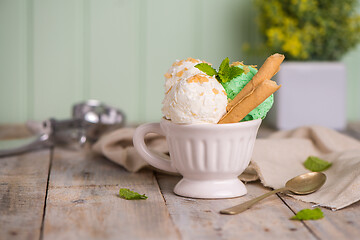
[218,80,281,124]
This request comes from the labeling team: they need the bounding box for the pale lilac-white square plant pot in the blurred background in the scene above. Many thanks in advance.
[266,62,346,130]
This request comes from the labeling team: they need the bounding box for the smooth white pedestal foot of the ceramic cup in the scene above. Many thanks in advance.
[174,178,247,198]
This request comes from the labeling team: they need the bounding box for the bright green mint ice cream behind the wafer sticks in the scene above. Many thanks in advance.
[221,65,274,121]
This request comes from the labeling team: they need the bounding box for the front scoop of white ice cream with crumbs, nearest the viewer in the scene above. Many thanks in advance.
[162,73,228,124]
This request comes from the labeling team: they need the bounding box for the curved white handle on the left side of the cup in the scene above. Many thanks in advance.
[133,123,178,173]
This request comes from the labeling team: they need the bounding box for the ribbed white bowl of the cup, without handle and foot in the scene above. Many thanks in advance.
[161,120,261,179]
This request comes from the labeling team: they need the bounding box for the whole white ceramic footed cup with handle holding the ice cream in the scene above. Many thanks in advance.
[133,118,261,198]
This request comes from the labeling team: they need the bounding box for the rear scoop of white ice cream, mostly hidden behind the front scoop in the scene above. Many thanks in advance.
[165,58,208,93]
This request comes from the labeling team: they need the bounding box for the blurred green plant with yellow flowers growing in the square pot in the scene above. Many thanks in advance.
[256,0,360,60]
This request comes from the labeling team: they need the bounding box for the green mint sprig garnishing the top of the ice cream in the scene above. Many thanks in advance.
[195,58,244,83]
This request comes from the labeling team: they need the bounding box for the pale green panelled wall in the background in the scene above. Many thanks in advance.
[0,0,360,123]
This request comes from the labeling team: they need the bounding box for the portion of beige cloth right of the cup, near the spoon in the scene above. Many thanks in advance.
[248,126,360,210]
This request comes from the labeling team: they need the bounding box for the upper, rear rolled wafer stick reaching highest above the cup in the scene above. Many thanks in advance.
[226,53,285,111]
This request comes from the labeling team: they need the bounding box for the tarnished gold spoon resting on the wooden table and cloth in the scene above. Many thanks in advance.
[220,172,326,215]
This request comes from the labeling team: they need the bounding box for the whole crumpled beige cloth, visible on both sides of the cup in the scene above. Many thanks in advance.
[93,126,360,210]
